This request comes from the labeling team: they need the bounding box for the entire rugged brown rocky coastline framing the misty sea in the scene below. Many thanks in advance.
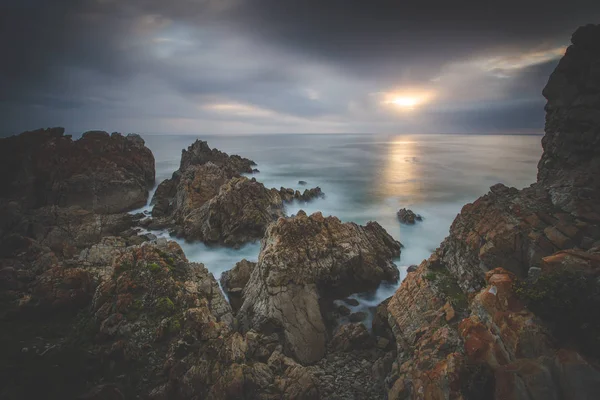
[0,25,600,400]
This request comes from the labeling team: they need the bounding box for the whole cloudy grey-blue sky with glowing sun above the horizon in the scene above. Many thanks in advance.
[0,0,600,135]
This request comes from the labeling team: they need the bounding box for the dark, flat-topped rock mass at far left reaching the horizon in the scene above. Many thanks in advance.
[0,128,154,213]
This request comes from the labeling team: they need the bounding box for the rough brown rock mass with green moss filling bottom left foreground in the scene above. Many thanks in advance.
[0,238,320,399]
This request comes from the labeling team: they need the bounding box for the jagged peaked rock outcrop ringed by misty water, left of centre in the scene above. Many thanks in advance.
[149,141,324,246]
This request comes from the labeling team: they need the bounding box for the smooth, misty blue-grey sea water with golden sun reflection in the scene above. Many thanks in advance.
[138,134,542,310]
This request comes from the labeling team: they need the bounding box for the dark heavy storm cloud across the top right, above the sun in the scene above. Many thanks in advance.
[229,0,600,79]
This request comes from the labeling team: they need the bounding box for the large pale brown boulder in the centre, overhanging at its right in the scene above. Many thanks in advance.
[238,211,401,363]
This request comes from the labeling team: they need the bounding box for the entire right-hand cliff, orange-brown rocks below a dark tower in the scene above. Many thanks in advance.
[387,25,600,400]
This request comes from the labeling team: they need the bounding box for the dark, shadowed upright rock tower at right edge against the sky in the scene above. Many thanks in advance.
[538,25,600,216]
